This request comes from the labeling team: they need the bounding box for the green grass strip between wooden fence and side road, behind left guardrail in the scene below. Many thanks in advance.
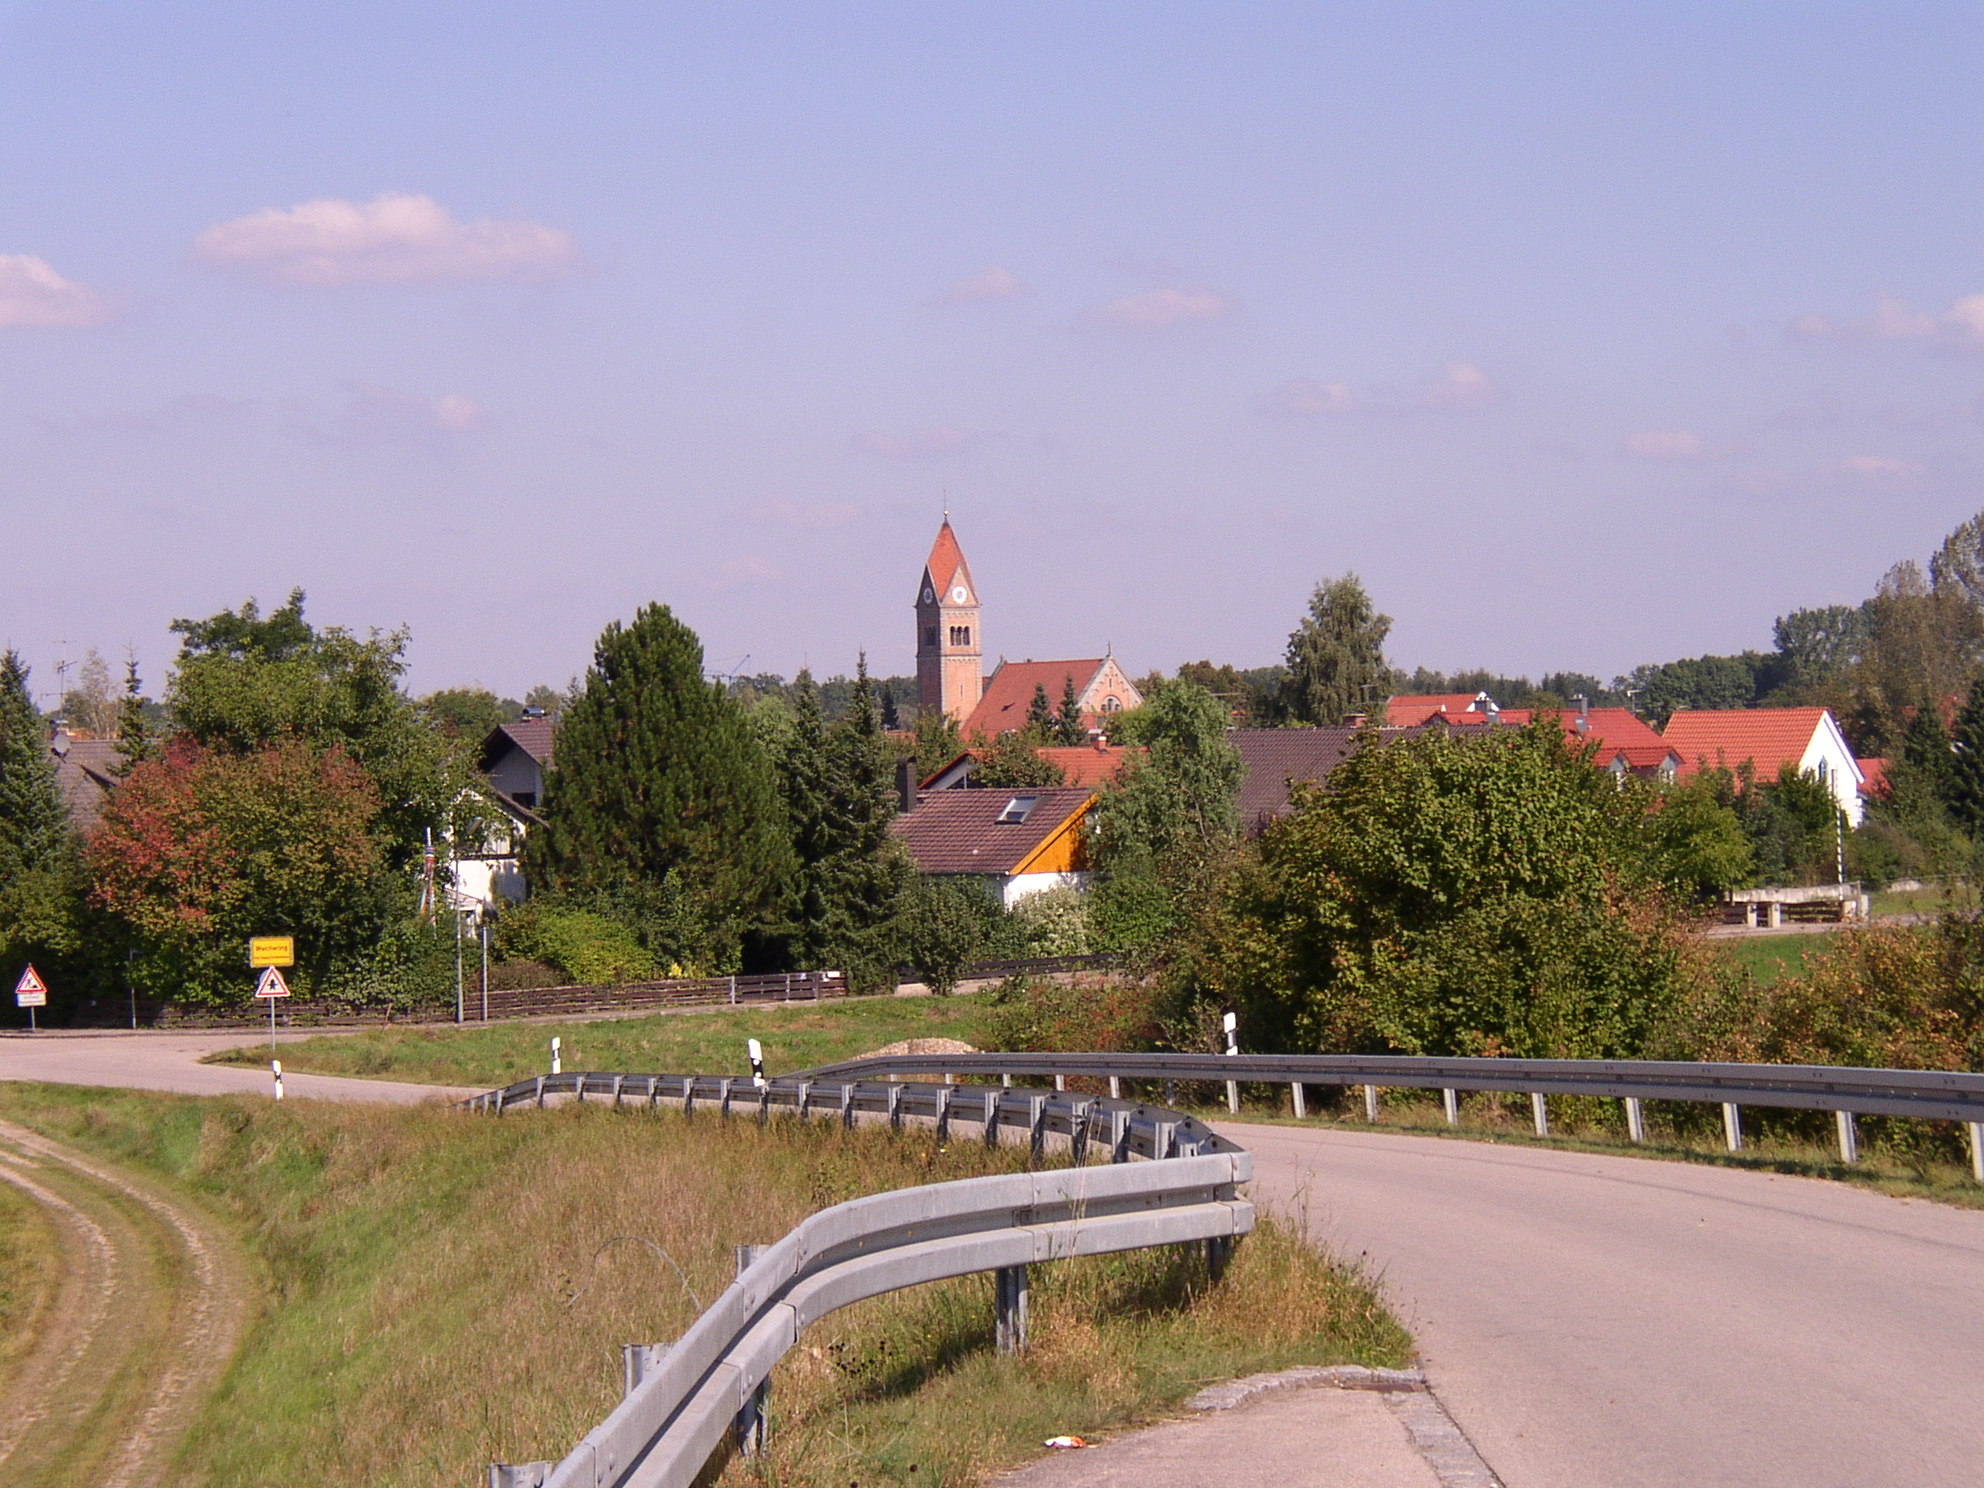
[208,998,992,1089]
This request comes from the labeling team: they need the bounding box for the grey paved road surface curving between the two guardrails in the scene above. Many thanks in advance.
[1220,1123,1984,1488]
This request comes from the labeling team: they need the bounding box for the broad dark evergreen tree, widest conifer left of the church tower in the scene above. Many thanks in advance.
[526,605,792,972]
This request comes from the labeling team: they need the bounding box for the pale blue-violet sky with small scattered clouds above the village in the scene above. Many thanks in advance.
[0,0,1984,694]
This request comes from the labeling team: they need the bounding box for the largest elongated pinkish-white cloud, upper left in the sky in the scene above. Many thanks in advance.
[192,196,579,288]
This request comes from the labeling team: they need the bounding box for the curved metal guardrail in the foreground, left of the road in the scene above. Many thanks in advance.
[462,1073,1254,1488]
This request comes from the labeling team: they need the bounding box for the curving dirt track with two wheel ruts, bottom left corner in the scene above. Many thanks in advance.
[0,1121,252,1488]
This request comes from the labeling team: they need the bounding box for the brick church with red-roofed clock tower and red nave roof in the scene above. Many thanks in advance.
[917,512,1143,742]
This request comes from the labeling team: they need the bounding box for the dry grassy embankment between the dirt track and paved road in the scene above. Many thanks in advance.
[0,1087,1411,1488]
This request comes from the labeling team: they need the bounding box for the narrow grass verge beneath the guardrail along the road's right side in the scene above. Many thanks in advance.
[1158,1085,1984,1208]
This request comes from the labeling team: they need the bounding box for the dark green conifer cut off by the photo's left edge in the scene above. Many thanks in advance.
[0,651,83,994]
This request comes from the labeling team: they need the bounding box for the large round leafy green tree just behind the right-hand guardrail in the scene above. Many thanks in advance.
[1206,720,1680,1057]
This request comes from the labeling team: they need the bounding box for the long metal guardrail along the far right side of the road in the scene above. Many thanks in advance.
[806,1054,1984,1182]
